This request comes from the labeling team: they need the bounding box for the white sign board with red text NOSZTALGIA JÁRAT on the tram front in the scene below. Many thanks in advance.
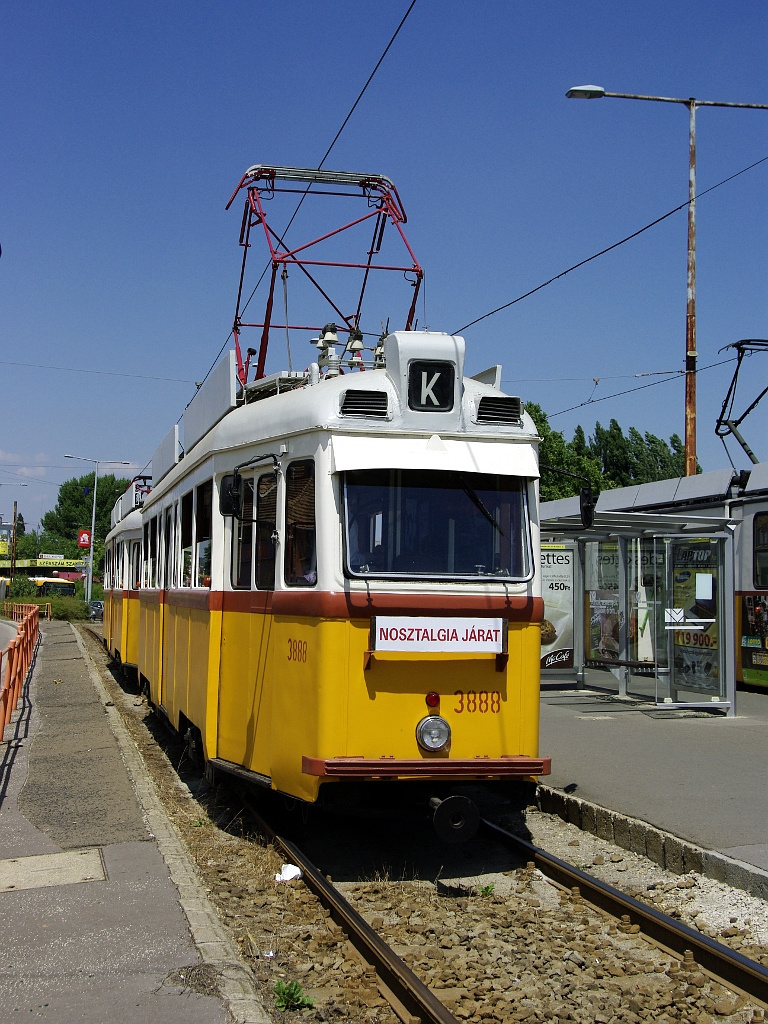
[371,615,506,654]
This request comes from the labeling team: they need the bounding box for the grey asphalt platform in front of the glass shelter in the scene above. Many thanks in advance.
[540,689,768,871]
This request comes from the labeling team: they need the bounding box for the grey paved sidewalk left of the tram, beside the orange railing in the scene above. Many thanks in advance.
[0,623,268,1024]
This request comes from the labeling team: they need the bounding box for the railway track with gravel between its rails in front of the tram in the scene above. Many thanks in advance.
[89,630,768,1024]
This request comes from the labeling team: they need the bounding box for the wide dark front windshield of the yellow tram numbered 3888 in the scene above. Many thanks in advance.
[344,469,531,581]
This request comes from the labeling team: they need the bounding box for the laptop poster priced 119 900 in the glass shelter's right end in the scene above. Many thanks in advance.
[671,541,721,695]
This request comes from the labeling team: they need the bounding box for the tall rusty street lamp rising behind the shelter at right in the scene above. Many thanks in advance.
[565,85,768,476]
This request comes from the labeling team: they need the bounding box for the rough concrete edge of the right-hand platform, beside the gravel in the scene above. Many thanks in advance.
[537,784,768,900]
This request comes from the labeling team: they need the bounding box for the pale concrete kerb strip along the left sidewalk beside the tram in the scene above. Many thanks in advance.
[71,625,271,1024]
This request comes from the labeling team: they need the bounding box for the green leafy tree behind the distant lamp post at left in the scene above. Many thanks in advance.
[40,473,130,558]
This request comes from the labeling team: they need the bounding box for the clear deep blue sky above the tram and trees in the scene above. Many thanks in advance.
[0,0,768,525]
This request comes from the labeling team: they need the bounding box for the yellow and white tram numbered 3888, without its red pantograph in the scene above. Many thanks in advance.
[105,332,549,835]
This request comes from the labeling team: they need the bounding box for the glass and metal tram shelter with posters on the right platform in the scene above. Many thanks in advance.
[541,498,735,716]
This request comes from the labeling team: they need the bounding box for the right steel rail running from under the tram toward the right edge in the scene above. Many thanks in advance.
[481,818,768,1006]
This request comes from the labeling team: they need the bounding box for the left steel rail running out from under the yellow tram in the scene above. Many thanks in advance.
[241,792,459,1024]
